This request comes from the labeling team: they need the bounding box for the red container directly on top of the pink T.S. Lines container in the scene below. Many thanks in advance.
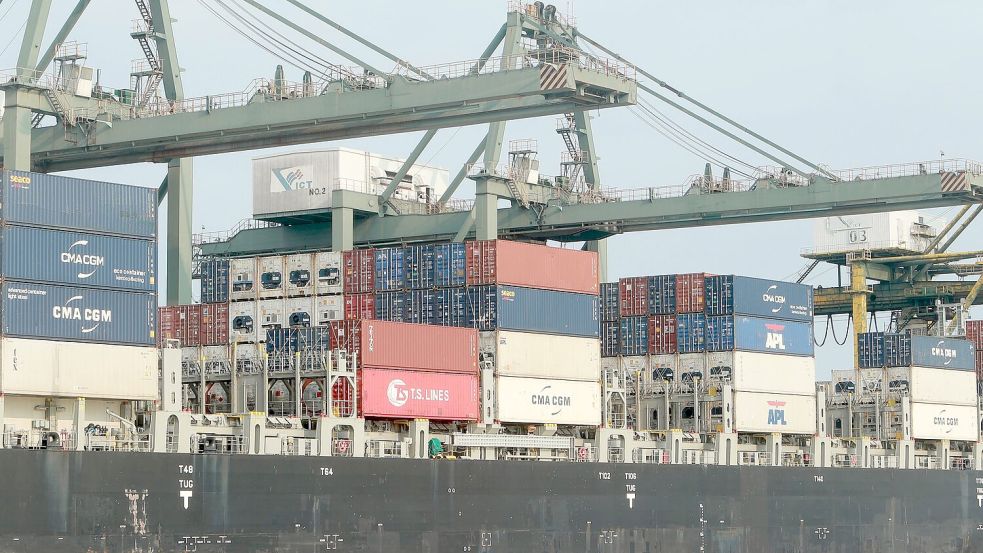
[359,321,478,374]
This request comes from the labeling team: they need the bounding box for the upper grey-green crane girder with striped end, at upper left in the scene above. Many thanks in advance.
[5,61,636,171]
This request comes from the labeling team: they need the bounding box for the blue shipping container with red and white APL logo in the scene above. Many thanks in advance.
[733,315,815,357]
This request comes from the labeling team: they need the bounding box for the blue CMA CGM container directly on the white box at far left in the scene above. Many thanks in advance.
[0,281,157,346]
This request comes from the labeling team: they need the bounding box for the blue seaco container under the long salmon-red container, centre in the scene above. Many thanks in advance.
[467,285,601,338]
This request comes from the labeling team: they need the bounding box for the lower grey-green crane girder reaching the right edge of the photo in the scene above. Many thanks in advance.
[202,169,983,257]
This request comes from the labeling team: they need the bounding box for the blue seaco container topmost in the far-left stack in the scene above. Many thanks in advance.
[0,171,157,238]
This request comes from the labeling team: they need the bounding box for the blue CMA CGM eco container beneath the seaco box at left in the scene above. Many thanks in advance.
[0,225,157,292]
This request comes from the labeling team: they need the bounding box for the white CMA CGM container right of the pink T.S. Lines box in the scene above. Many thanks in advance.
[495,376,601,426]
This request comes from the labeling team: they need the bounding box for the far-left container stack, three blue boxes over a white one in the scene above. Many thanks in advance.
[0,171,157,400]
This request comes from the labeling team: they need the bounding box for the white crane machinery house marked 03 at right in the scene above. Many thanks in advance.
[813,211,932,253]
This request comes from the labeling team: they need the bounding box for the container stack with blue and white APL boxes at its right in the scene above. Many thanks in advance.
[601,273,815,433]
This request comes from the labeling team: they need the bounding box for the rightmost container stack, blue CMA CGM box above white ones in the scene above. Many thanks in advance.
[857,332,979,441]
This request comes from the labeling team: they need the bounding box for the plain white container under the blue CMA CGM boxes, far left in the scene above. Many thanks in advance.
[0,338,158,401]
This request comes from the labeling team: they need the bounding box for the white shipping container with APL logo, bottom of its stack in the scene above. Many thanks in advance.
[734,392,816,434]
